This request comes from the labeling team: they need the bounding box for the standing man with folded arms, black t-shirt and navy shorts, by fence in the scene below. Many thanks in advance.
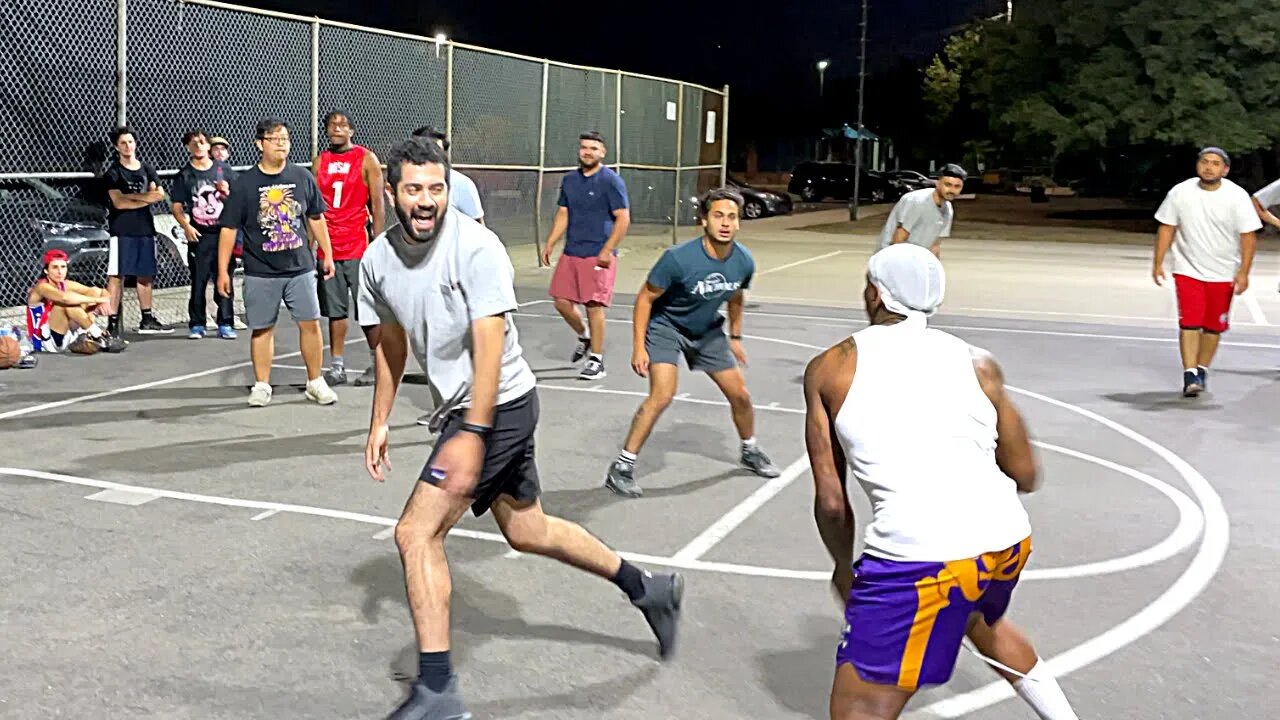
[104,127,173,337]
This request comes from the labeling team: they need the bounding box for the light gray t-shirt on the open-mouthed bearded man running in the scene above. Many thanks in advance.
[360,211,536,407]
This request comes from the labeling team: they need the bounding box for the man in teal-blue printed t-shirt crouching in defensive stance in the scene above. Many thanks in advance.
[604,187,781,497]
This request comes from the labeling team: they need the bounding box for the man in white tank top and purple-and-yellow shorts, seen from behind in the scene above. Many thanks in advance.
[804,243,1076,720]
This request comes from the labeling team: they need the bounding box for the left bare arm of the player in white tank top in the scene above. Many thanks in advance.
[804,341,856,571]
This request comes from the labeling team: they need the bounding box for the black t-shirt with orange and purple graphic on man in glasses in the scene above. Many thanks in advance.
[221,163,325,278]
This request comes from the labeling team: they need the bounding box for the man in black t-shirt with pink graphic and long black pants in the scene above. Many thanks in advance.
[173,131,236,340]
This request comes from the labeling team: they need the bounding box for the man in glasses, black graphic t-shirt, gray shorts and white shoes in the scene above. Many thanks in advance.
[218,119,338,407]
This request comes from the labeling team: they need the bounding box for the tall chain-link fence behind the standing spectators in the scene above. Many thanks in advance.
[0,0,728,328]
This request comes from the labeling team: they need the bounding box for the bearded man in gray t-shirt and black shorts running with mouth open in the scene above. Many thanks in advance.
[360,137,684,717]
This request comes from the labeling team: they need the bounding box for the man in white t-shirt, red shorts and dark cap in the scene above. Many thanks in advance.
[1151,147,1262,397]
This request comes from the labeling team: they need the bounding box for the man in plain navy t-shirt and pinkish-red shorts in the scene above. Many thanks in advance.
[543,132,631,380]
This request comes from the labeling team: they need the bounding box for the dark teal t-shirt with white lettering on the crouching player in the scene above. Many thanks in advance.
[648,237,755,337]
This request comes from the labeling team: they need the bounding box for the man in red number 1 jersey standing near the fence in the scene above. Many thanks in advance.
[311,110,385,387]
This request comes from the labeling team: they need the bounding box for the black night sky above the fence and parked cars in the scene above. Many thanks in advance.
[239,0,1005,155]
